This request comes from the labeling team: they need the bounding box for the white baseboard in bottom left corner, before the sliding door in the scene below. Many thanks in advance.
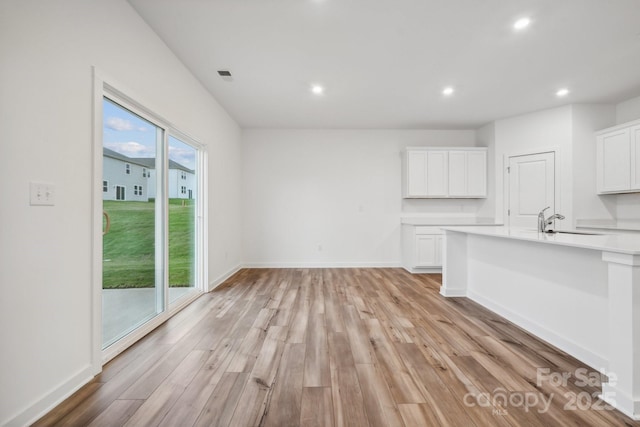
[0,365,94,427]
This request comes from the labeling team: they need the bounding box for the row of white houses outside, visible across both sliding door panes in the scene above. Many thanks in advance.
[102,148,196,202]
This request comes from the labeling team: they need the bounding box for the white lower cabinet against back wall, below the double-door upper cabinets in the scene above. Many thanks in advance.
[402,224,443,272]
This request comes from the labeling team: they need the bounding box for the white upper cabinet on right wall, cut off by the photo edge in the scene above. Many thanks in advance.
[596,121,640,194]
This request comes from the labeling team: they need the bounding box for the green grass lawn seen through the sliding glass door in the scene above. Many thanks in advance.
[102,199,195,289]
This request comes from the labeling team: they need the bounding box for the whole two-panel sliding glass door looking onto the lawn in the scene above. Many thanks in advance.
[102,97,199,349]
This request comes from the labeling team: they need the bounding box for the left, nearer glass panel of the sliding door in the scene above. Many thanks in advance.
[102,98,164,348]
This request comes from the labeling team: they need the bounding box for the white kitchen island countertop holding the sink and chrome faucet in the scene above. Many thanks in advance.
[442,226,640,255]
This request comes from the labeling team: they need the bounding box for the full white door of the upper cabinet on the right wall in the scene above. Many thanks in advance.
[597,129,631,193]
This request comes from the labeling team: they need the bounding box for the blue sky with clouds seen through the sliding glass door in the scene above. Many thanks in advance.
[103,99,196,170]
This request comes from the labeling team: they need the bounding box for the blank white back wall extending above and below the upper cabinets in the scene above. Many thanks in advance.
[242,129,478,266]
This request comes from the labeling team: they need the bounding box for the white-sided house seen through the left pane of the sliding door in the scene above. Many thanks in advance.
[102,148,151,202]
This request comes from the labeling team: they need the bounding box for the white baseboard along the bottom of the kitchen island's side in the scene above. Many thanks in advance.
[467,290,609,370]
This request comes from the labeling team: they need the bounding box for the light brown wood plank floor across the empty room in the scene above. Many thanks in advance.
[36,269,640,427]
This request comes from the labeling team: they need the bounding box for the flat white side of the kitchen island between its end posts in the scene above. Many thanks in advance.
[466,234,609,369]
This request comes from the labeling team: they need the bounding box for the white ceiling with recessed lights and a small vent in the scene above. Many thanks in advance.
[129,0,640,129]
